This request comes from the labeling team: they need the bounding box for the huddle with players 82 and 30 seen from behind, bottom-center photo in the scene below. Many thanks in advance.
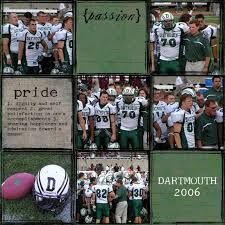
[76,164,150,224]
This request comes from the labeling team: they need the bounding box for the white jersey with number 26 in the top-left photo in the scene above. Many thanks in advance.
[18,30,43,67]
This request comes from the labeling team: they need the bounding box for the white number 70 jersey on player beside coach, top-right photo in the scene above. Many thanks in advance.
[153,23,188,61]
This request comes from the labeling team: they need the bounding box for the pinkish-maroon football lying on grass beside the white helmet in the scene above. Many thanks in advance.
[2,173,35,200]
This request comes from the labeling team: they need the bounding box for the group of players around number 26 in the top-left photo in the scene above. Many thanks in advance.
[2,11,73,75]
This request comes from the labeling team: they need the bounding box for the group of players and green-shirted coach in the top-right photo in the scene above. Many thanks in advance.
[149,9,218,75]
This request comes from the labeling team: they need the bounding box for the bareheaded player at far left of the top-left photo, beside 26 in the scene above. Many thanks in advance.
[2,13,24,70]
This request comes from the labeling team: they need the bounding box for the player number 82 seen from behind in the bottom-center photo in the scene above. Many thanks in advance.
[92,177,115,224]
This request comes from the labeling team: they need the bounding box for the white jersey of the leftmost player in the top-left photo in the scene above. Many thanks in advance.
[2,23,24,54]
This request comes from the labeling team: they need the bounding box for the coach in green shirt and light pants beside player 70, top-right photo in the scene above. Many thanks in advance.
[183,20,210,74]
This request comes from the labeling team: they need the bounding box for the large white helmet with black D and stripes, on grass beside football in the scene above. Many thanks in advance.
[33,164,70,214]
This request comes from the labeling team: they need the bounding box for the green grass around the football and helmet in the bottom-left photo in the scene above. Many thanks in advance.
[3,152,71,221]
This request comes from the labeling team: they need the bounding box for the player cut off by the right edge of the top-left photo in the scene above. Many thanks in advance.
[56,17,73,74]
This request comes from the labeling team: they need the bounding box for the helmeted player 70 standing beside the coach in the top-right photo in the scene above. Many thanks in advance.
[150,12,188,75]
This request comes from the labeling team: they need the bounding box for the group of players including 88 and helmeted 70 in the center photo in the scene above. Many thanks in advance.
[77,78,149,151]
